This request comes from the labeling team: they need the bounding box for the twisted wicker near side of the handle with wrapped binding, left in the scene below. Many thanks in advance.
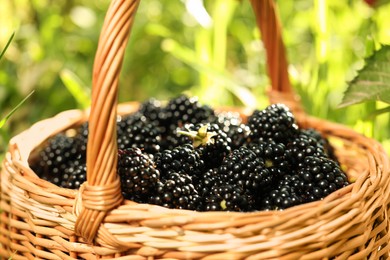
[75,0,139,243]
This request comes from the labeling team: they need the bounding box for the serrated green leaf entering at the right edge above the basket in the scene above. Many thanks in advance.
[339,45,390,107]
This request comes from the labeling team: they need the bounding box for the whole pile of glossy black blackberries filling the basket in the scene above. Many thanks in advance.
[31,95,349,212]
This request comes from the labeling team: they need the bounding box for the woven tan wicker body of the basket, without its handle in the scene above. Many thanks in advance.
[0,103,390,259]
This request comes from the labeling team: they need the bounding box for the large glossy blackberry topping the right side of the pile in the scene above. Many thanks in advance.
[248,104,298,144]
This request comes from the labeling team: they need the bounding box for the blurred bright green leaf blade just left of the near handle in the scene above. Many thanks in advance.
[60,69,90,109]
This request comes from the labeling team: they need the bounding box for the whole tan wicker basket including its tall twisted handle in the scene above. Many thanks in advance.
[0,0,390,260]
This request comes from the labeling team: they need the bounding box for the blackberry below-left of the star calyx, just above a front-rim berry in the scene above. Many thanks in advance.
[154,144,204,178]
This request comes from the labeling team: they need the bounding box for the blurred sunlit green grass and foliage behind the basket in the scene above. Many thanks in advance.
[0,0,390,154]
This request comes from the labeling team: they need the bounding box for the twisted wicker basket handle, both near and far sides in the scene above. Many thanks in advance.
[75,0,292,242]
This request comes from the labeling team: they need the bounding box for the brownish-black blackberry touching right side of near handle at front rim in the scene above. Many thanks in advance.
[117,148,160,203]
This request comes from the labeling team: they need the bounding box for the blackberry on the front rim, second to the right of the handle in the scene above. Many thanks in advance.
[148,172,202,210]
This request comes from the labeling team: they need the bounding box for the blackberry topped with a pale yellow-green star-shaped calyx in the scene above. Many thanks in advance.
[178,124,231,168]
